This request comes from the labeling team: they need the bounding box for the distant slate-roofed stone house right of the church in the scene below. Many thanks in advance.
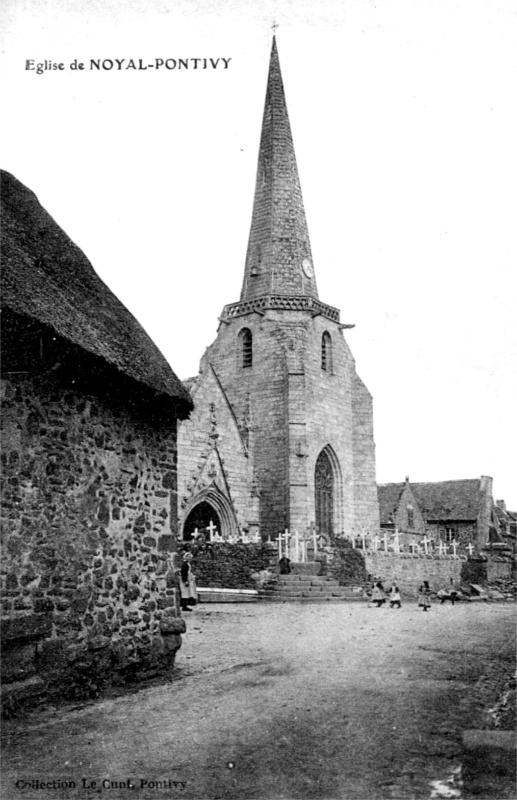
[377,475,502,554]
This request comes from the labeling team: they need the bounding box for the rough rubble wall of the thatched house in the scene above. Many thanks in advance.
[1,374,184,708]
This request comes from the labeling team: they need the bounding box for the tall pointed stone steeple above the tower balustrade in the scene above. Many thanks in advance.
[241,37,318,302]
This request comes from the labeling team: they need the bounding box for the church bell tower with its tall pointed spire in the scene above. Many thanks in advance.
[198,38,379,538]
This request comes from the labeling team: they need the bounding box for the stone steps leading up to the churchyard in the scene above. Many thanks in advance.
[258,573,362,603]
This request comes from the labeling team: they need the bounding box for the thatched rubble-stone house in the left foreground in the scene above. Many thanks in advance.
[1,172,192,705]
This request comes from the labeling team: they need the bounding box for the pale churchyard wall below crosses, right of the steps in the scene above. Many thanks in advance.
[365,552,466,597]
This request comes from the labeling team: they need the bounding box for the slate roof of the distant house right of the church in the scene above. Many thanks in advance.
[377,478,481,525]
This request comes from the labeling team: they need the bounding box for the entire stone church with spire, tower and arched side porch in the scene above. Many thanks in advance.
[178,39,379,541]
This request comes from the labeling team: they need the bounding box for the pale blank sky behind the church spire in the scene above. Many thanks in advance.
[0,0,517,510]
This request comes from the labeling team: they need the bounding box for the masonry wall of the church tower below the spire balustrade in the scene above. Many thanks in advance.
[206,310,378,538]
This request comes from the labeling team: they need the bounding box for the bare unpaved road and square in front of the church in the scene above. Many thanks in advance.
[2,603,515,800]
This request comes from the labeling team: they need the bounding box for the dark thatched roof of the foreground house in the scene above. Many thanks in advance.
[0,171,192,418]
